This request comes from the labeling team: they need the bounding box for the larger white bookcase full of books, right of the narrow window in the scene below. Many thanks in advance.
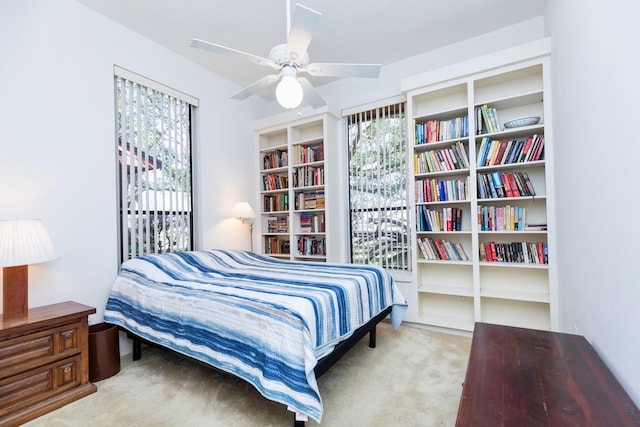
[404,42,558,331]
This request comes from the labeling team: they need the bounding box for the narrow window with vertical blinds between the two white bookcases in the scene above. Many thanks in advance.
[347,102,410,270]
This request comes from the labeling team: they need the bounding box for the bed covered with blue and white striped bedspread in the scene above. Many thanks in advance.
[104,249,407,425]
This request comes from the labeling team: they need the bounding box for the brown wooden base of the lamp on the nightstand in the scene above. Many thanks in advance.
[2,265,29,320]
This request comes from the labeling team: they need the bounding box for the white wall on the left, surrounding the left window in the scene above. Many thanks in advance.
[0,0,260,323]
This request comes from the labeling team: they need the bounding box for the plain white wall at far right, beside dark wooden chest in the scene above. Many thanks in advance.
[548,0,640,404]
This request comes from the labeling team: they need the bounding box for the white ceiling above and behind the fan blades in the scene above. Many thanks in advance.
[76,0,547,94]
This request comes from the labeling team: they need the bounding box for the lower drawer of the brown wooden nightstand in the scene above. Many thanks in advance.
[0,354,81,417]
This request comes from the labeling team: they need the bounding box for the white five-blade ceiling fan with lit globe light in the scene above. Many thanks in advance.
[191,2,381,108]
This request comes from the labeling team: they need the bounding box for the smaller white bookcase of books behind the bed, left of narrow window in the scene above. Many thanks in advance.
[256,112,339,261]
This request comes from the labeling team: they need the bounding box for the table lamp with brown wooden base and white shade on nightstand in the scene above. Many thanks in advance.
[0,219,58,320]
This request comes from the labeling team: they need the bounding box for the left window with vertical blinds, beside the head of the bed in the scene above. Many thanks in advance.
[115,69,197,262]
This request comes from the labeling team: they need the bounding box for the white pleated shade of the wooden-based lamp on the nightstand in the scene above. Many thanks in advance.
[0,219,58,267]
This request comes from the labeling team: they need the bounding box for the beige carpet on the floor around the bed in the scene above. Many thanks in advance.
[26,322,471,427]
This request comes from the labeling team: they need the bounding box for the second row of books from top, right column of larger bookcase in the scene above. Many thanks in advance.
[477,135,544,167]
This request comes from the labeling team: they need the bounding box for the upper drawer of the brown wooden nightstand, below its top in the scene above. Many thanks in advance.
[0,322,82,379]
